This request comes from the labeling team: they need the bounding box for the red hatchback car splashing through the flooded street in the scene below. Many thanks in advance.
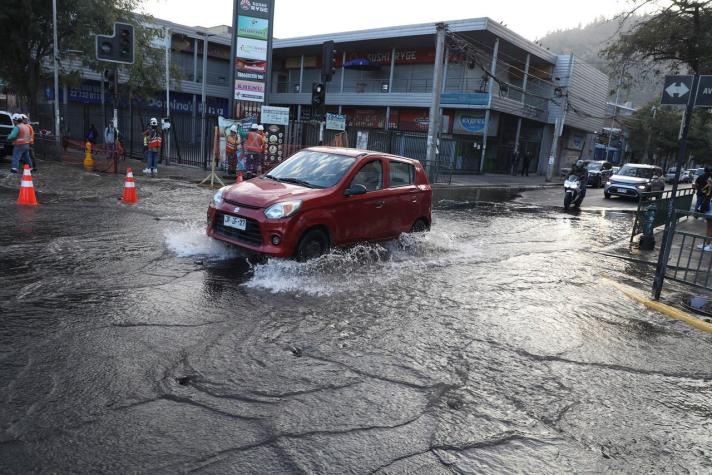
[207,147,432,261]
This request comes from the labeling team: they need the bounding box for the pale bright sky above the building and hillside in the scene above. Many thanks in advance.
[143,0,630,40]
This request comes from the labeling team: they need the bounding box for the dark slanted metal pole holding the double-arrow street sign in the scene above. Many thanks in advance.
[653,74,700,300]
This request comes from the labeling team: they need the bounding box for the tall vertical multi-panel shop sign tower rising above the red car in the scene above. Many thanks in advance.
[233,0,274,108]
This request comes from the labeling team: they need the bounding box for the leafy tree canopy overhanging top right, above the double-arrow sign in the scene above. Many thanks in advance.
[603,0,712,74]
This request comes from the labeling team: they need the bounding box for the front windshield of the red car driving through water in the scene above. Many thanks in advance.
[265,150,356,188]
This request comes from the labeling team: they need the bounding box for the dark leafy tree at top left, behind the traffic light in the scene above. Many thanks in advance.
[0,0,178,114]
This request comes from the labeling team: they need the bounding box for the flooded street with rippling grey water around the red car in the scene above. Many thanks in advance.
[0,164,712,473]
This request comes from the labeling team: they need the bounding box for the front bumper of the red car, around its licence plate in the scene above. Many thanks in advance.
[206,204,299,257]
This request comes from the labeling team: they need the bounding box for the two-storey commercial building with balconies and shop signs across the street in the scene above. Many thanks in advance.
[40,18,608,177]
